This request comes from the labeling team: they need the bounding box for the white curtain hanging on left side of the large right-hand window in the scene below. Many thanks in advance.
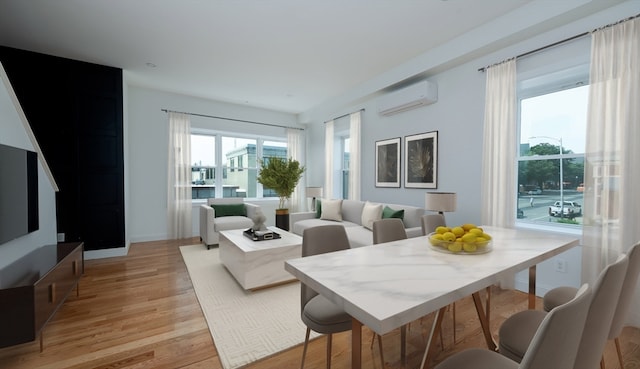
[481,59,517,227]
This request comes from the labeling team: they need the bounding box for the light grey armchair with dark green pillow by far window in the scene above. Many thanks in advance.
[200,197,260,249]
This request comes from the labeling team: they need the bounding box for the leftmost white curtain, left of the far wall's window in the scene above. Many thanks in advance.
[167,112,193,239]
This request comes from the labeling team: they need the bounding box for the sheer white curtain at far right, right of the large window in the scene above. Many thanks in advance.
[582,18,640,326]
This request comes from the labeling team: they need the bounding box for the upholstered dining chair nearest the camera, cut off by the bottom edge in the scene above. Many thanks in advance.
[435,284,592,369]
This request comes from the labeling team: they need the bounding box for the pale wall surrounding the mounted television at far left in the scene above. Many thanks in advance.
[0,64,57,274]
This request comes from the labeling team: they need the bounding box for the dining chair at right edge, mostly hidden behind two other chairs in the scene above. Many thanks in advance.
[544,243,640,368]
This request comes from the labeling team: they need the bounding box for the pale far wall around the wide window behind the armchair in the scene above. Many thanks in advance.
[125,86,303,242]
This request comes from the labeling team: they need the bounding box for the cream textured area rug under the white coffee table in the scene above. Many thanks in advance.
[180,245,317,369]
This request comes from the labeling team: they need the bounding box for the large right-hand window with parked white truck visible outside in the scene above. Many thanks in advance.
[517,81,589,226]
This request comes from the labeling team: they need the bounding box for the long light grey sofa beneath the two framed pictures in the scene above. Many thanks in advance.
[289,200,424,248]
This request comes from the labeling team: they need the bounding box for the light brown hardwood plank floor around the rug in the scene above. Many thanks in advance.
[0,239,640,369]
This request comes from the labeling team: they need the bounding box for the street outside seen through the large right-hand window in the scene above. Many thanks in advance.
[518,190,584,224]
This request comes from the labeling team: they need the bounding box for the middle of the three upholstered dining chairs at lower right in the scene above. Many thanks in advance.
[499,255,629,369]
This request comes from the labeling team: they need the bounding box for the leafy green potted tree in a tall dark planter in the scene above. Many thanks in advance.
[256,156,305,231]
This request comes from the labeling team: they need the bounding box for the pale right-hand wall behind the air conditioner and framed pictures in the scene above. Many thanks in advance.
[302,2,638,294]
